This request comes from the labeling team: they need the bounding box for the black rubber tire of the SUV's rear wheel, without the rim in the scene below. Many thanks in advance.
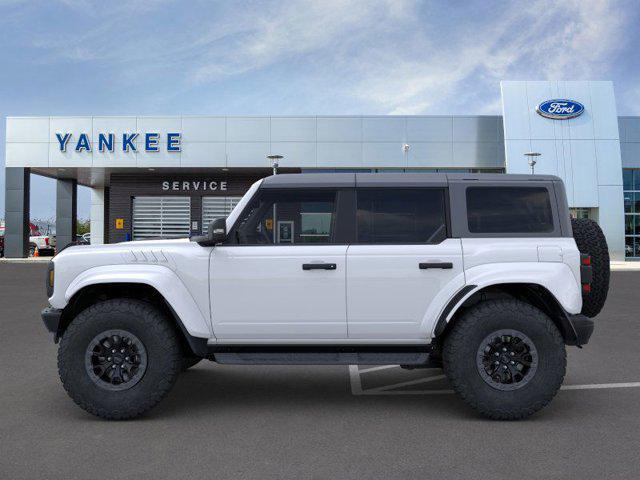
[443,299,567,420]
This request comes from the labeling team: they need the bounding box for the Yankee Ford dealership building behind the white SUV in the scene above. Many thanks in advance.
[5,81,640,260]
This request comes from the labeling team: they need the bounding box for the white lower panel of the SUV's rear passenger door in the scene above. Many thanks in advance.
[347,238,465,341]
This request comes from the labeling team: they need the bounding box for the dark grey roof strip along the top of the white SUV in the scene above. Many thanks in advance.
[261,172,560,188]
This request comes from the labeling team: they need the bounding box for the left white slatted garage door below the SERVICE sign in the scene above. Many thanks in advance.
[133,197,191,240]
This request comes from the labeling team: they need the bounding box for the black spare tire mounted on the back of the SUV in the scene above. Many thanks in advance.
[571,218,610,317]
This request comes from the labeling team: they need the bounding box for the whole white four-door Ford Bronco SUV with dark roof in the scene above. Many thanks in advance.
[42,173,609,419]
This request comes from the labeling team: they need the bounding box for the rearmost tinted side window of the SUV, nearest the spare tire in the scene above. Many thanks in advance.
[467,187,553,233]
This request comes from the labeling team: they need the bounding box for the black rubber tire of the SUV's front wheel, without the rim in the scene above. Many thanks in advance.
[58,298,182,420]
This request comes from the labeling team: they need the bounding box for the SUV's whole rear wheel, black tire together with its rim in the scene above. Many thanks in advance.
[443,299,567,420]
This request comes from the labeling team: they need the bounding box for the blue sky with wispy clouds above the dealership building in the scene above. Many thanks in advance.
[0,0,640,219]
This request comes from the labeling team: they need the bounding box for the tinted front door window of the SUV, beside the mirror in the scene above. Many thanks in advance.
[230,190,336,245]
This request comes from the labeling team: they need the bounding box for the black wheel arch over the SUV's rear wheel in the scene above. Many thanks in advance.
[434,283,577,345]
